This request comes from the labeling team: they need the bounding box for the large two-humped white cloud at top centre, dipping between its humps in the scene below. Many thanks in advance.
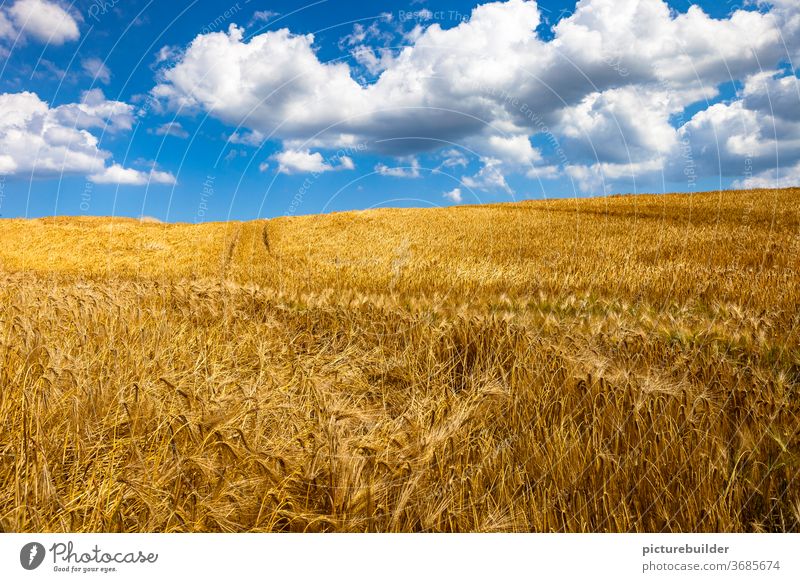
[153,0,538,153]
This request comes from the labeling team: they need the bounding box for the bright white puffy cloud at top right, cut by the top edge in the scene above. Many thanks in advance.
[555,0,785,88]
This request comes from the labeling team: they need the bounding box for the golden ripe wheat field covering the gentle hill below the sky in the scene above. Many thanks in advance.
[0,189,800,532]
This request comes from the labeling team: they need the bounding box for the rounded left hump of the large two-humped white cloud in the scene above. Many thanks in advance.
[153,26,366,137]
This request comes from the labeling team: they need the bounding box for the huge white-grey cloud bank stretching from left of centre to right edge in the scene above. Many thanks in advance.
[152,0,800,193]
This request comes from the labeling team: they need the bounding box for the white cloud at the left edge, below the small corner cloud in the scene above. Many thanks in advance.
[0,90,167,183]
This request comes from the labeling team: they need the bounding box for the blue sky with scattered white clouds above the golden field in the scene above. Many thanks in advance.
[0,0,800,222]
